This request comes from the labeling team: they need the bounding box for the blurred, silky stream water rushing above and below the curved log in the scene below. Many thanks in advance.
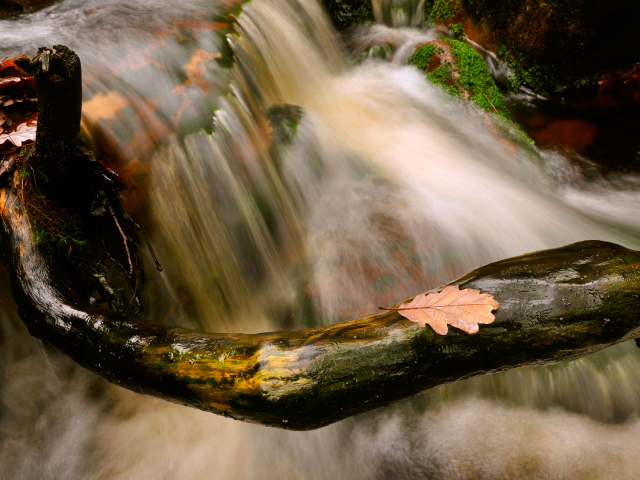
[0,0,640,479]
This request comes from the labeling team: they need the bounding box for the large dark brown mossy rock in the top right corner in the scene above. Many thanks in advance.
[427,0,640,93]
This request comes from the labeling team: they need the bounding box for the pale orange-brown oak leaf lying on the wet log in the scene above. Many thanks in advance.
[380,285,500,335]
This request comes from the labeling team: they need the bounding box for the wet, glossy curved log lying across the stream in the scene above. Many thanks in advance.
[0,179,640,430]
